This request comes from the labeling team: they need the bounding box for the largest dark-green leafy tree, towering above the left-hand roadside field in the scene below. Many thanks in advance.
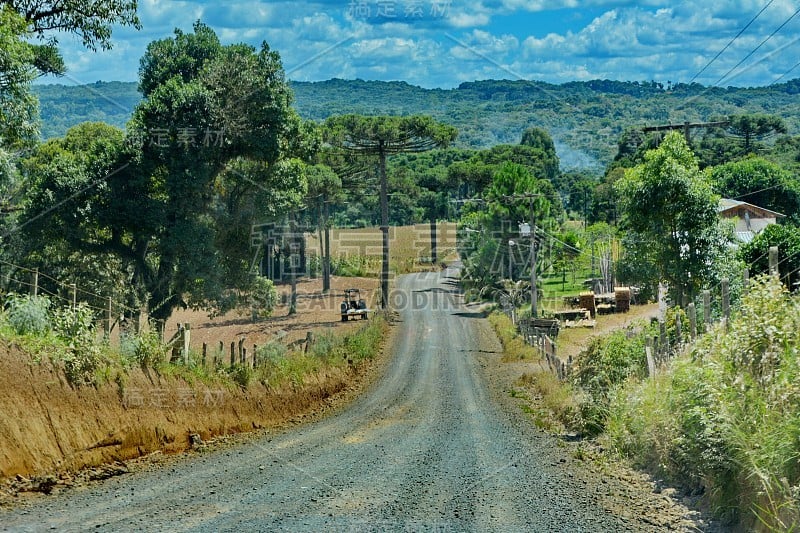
[18,23,314,320]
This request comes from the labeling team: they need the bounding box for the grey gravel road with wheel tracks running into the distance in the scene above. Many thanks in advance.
[0,271,692,531]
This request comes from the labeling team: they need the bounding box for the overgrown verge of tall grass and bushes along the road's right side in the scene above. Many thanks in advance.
[493,278,800,531]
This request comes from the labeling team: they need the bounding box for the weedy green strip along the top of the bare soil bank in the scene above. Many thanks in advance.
[0,296,387,388]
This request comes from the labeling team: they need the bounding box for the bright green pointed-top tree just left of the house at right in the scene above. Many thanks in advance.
[616,132,725,304]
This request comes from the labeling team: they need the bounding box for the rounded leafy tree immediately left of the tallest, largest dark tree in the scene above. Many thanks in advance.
[16,123,129,309]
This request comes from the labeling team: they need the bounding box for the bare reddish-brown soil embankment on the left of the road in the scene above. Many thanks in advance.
[0,350,371,479]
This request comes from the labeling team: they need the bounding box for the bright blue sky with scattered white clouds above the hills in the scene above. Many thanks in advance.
[43,0,800,88]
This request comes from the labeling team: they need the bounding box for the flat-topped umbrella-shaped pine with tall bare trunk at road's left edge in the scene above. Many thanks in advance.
[326,115,458,308]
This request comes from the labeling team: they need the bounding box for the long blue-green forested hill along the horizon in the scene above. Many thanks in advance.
[35,79,800,170]
